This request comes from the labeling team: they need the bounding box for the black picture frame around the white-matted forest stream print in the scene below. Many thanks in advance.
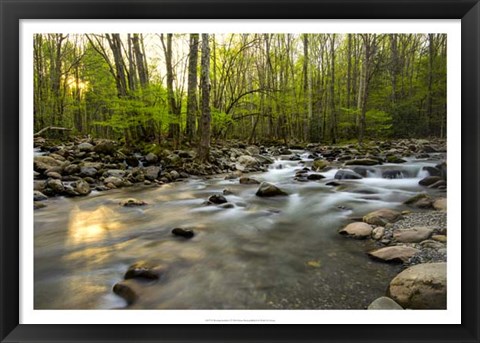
[0,0,480,342]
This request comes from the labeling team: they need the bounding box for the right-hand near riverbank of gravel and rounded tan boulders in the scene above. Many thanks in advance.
[339,197,447,310]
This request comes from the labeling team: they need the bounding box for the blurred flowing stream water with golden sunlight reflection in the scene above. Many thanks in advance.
[34,154,442,309]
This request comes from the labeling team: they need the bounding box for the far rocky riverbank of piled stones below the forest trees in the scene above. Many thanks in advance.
[33,137,446,208]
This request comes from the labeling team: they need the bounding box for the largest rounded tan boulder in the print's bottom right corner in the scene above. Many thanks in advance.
[388,262,447,309]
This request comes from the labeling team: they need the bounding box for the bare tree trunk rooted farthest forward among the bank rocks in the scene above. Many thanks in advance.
[197,33,211,162]
